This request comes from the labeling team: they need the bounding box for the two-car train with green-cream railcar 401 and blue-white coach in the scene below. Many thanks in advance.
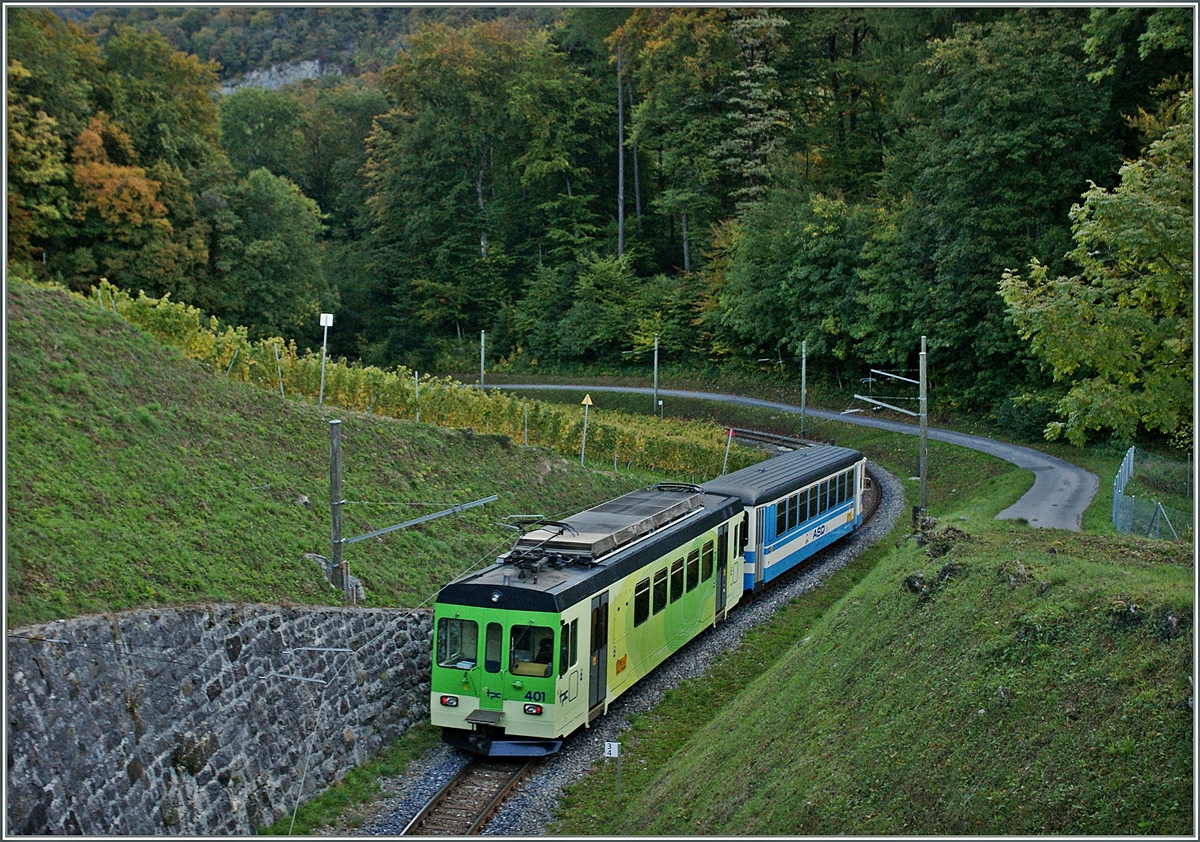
[430,445,866,756]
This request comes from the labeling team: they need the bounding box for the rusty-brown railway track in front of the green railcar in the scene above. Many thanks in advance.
[401,758,536,836]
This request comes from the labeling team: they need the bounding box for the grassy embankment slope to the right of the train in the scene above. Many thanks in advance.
[554,483,1195,835]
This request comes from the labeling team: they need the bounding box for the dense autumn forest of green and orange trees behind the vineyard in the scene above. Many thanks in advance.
[6,6,1194,446]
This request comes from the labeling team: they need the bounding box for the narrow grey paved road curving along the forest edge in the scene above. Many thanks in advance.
[488,384,1099,533]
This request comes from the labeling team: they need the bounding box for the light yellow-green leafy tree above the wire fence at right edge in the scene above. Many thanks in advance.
[1001,90,1195,445]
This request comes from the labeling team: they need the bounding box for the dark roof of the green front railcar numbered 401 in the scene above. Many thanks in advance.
[438,483,742,613]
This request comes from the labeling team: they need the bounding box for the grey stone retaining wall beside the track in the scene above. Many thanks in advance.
[5,605,432,836]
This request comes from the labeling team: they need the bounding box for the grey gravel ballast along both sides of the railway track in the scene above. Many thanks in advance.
[353,464,904,836]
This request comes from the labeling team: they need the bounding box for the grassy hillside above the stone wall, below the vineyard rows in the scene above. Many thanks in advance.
[5,279,647,627]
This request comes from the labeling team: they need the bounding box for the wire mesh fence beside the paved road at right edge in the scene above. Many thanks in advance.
[1112,447,1193,541]
